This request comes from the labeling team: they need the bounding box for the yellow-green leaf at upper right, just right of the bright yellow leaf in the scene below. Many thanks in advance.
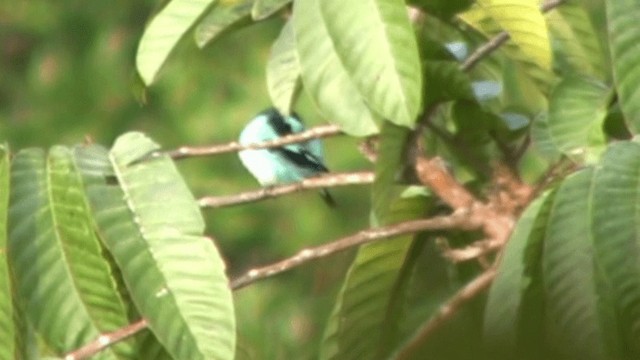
[546,1,607,81]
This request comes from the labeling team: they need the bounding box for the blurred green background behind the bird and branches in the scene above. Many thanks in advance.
[0,0,370,359]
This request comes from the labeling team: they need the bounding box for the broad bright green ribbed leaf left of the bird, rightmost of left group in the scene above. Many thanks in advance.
[76,133,235,359]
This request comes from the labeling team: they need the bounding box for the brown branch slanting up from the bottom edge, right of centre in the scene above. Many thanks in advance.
[393,268,497,360]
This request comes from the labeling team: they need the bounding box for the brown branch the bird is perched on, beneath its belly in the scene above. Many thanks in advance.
[198,171,374,208]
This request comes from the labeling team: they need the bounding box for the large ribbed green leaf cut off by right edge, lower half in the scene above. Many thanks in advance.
[592,142,640,359]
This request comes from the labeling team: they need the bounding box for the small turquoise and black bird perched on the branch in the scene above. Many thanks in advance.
[238,107,335,207]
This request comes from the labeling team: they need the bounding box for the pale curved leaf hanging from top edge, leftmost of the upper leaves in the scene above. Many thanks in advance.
[136,0,217,85]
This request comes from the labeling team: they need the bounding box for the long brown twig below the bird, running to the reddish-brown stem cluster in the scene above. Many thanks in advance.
[231,213,478,290]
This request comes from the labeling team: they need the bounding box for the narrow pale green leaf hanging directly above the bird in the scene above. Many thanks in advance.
[267,21,300,114]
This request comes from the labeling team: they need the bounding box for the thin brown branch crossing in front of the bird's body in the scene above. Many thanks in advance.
[159,125,342,159]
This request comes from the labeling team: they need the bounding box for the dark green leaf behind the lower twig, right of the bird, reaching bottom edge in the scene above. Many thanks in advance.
[320,122,426,359]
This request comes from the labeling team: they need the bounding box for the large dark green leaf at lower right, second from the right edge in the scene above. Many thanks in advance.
[543,168,620,360]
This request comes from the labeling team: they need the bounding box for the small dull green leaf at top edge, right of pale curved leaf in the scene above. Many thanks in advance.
[195,0,253,48]
